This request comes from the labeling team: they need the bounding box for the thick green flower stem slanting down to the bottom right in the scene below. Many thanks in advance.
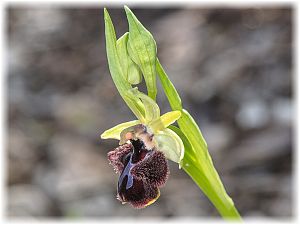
[156,56,241,219]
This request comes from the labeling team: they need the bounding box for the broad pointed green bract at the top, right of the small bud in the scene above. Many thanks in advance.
[124,6,157,100]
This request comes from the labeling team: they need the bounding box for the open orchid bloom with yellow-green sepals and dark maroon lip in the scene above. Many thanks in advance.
[101,89,184,208]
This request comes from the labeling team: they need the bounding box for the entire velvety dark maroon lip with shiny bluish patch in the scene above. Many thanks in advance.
[108,139,169,208]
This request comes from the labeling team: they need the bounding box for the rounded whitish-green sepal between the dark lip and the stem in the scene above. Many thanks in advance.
[154,128,184,165]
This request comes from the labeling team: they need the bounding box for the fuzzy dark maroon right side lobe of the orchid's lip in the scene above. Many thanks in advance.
[131,151,170,187]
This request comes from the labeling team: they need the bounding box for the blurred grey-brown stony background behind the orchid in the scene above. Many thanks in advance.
[6,5,294,218]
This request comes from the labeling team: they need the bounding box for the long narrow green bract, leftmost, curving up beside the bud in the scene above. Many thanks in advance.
[104,9,145,118]
